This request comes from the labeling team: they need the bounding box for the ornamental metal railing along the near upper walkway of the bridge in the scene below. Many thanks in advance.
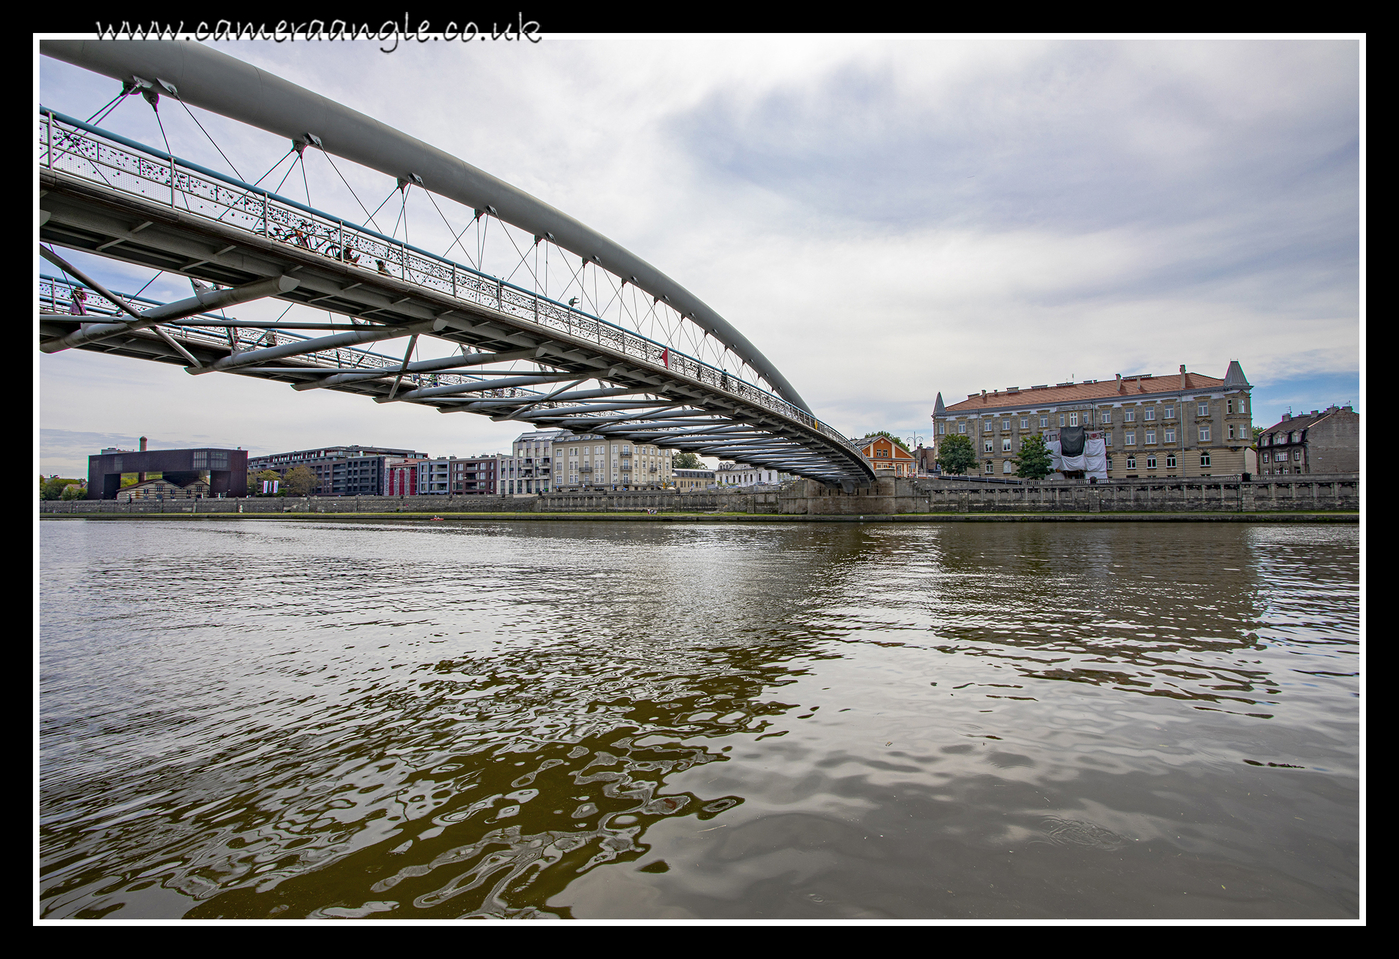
[39,106,860,456]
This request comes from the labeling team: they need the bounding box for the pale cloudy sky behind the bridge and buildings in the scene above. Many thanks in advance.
[35,34,1364,476]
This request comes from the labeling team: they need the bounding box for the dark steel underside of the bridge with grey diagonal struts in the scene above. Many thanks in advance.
[39,163,873,489]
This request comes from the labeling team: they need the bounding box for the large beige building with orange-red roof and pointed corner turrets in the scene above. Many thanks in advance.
[933,360,1254,479]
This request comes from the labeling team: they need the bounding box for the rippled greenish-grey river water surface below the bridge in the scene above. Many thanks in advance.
[39,521,1360,918]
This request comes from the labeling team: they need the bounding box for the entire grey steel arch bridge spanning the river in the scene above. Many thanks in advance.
[38,41,874,489]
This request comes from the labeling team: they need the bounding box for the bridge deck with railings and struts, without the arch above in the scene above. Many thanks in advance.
[39,111,873,486]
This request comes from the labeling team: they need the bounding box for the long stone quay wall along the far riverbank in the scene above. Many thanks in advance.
[39,473,1360,517]
